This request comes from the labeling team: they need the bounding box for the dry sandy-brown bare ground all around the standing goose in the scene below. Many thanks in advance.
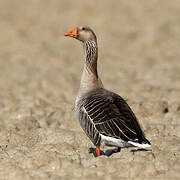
[0,0,180,180]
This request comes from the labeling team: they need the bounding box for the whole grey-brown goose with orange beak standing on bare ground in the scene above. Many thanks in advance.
[64,27,151,156]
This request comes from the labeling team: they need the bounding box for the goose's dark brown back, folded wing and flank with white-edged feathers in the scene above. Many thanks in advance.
[76,88,148,146]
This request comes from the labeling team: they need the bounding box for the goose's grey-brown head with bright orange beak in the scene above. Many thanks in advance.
[64,26,96,43]
